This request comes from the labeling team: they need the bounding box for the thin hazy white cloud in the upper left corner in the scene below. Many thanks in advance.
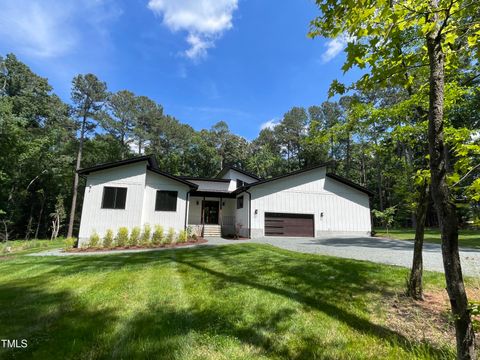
[0,0,120,58]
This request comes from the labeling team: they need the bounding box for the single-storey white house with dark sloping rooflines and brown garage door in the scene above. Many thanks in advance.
[78,156,371,244]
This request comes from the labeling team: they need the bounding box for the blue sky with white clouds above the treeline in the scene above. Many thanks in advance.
[0,0,355,140]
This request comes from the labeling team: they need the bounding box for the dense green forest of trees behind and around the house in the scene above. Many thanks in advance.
[0,54,480,240]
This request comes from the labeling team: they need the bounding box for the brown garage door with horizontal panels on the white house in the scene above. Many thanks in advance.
[265,213,314,236]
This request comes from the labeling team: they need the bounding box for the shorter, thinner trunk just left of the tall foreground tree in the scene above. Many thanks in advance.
[407,181,429,300]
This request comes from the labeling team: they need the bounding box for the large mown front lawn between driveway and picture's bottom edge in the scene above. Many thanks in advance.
[0,244,460,359]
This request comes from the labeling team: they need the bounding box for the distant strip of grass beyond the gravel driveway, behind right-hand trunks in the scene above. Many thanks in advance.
[375,229,480,249]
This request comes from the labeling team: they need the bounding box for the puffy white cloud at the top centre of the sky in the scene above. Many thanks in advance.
[148,0,238,59]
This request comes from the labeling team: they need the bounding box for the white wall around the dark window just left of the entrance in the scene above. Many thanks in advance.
[142,171,189,232]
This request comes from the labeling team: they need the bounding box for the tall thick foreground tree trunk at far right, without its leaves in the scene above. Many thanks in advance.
[426,23,476,359]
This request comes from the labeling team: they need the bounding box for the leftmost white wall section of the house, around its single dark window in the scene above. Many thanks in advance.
[78,162,146,244]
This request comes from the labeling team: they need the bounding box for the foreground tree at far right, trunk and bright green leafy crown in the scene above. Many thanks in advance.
[310,0,480,359]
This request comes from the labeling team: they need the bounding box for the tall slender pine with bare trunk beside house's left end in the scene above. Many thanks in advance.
[67,74,107,237]
